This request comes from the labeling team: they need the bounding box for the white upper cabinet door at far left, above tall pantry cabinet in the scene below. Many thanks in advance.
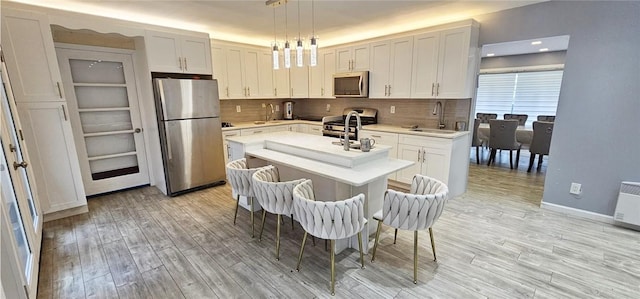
[1,7,64,102]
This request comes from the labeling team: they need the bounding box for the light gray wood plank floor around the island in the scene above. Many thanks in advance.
[38,160,640,298]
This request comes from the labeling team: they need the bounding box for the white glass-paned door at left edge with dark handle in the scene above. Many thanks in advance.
[0,63,42,298]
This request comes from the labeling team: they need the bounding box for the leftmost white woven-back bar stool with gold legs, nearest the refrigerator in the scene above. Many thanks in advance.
[226,158,260,238]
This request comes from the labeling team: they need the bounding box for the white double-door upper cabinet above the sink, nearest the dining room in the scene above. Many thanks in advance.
[411,25,478,98]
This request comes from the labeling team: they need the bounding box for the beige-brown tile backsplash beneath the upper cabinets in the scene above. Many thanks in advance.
[220,98,471,130]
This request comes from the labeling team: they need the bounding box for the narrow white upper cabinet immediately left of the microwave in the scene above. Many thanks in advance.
[309,50,336,98]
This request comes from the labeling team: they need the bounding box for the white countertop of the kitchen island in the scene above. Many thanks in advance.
[227,132,414,186]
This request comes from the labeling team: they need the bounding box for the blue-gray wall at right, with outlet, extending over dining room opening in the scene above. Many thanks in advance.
[474,1,640,215]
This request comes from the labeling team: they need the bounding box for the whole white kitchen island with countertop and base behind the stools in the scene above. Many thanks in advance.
[227,132,414,251]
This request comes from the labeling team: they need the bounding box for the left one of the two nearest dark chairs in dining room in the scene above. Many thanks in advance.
[487,119,522,169]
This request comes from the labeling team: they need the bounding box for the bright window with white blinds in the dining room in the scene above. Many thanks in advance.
[476,70,563,126]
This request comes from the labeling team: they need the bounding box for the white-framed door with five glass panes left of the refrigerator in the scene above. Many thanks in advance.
[56,48,149,195]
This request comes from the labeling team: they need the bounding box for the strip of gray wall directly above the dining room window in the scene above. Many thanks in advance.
[480,51,567,70]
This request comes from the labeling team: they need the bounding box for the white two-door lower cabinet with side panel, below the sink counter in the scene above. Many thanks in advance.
[397,134,469,197]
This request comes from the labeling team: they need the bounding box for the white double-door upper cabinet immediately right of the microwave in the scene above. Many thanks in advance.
[369,37,413,98]
